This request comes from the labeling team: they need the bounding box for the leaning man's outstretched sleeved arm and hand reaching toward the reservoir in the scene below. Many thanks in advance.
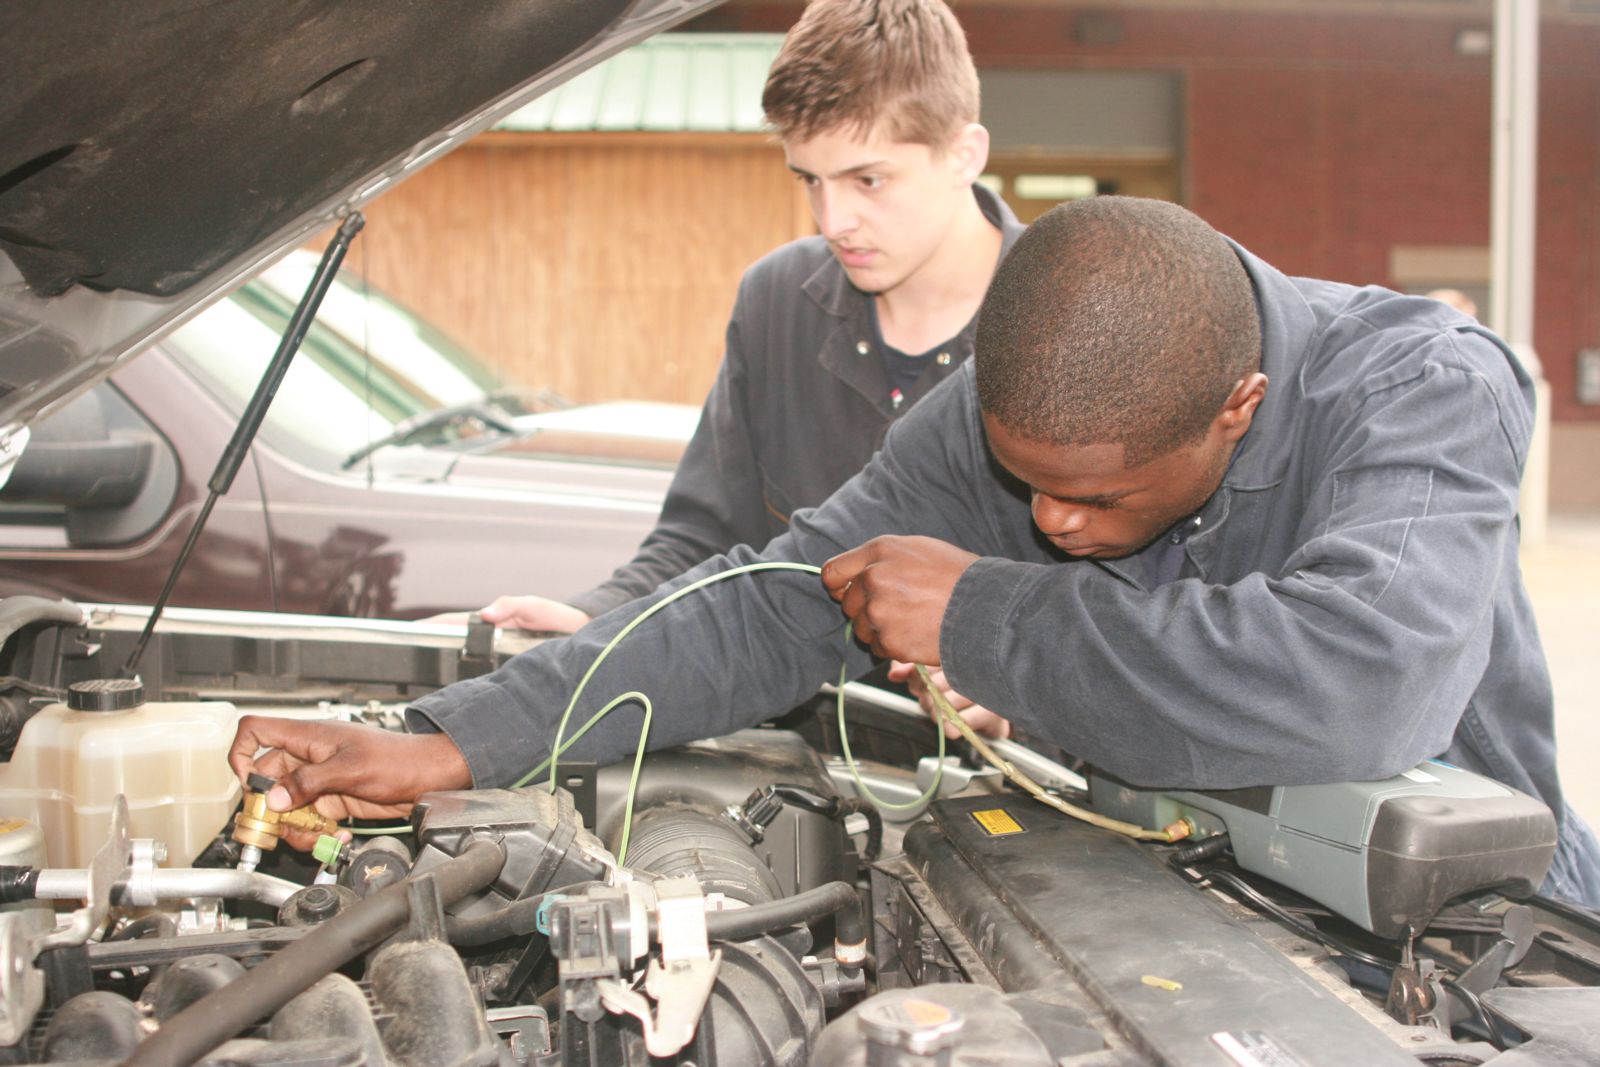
[235,374,987,825]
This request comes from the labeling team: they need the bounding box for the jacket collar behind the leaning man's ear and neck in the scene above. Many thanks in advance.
[1222,240,1317,491]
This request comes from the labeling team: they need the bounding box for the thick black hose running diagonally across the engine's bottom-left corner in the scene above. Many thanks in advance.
[123,838,506,1067]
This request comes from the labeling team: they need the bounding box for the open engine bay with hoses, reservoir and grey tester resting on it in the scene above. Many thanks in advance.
[0,598,1600,1067]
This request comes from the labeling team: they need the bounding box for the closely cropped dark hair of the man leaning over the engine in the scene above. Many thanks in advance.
[973,197,1261,467]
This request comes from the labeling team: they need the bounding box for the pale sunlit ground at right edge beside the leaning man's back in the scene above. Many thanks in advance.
[1522,509,1600,827]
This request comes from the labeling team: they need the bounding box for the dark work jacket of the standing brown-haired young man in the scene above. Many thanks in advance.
[571,186,1022,616]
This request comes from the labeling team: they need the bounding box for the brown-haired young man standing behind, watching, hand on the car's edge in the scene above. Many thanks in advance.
[483,0,1022,632]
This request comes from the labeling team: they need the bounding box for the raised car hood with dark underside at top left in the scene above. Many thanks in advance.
[0,0,717,447]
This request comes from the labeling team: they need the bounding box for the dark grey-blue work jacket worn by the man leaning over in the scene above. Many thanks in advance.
[414,241,1600,904]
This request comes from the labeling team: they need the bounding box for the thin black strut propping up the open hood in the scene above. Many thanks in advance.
[122,211,366,678]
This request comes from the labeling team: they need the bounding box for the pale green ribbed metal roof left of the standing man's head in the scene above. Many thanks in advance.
[496,34,784,133]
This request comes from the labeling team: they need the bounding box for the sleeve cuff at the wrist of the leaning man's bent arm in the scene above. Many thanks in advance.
[939,557,1040,707]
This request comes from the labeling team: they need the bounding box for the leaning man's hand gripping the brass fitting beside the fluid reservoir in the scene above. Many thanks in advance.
[227,715,472,849]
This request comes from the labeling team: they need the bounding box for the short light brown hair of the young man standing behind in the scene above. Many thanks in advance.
[762,0,978,149]
